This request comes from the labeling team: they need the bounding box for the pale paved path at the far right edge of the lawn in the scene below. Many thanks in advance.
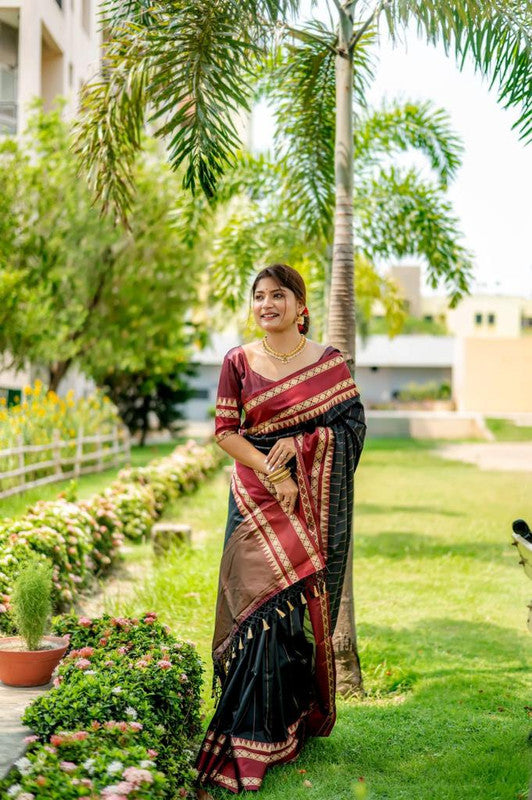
[434,442,532,472]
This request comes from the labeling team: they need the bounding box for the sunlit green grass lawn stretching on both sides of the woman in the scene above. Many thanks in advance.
[89,440,532,800]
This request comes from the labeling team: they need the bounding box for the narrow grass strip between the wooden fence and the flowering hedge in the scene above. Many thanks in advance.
[0,440,180,517]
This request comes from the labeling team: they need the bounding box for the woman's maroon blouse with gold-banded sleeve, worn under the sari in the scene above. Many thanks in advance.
[215,345,334,442]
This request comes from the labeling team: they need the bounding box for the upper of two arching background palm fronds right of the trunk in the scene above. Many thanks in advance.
[354,101,463,187]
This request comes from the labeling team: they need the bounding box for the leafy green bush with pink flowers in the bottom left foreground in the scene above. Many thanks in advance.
[0,612,202,800]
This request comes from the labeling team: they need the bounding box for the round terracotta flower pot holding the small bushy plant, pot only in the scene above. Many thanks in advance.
[0,636,68,686]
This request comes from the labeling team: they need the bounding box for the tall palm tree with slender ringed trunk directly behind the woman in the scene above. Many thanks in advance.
[78,0,532,687]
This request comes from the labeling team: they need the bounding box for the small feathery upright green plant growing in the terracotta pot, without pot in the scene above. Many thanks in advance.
[11,556,52,650]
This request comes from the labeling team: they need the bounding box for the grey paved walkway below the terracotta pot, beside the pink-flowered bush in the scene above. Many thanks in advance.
[0,682,52,778]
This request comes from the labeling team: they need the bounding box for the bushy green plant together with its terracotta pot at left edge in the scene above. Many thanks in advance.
[0,557,68,686]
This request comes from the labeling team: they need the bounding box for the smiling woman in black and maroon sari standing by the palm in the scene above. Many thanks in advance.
[196,264,366,792]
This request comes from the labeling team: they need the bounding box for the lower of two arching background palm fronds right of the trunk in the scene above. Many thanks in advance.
[354,167,472,304]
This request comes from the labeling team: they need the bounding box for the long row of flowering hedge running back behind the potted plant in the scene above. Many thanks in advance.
[0,441,223,633]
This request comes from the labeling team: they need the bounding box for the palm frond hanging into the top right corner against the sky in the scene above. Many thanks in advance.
[385,0,532,141]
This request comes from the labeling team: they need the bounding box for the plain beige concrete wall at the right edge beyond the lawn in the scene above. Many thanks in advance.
[455,336,532,414]
